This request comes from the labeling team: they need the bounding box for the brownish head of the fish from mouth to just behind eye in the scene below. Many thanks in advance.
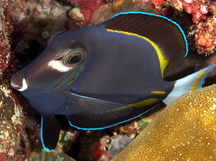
[11,30,87,94]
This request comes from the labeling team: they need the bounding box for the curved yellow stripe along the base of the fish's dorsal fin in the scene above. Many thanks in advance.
[106,29,169,77]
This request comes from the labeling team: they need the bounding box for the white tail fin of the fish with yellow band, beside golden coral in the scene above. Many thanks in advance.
[163,64,216,105]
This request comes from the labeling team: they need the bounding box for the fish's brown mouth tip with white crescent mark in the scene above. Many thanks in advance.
[11,73,28,91]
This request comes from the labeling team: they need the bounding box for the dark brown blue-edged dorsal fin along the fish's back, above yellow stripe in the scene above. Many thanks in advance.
[103,12,188,60]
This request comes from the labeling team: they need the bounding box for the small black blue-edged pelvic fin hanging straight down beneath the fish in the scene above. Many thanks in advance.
[40,115,61,152]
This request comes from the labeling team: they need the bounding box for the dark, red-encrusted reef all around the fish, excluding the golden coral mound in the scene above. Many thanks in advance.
[0,0,216,161]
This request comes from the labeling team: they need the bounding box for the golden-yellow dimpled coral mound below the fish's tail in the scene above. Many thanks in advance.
[113,85,216,161]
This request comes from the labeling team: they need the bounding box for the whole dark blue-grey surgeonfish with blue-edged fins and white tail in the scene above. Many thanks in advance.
[11,12,215,151]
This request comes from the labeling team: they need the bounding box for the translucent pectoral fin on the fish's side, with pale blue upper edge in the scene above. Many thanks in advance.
[67,93,132,120]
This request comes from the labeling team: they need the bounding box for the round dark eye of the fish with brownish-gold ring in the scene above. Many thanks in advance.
[63,48,86,67]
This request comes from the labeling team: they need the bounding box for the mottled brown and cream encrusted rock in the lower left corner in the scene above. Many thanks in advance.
[0,85,30,161]
